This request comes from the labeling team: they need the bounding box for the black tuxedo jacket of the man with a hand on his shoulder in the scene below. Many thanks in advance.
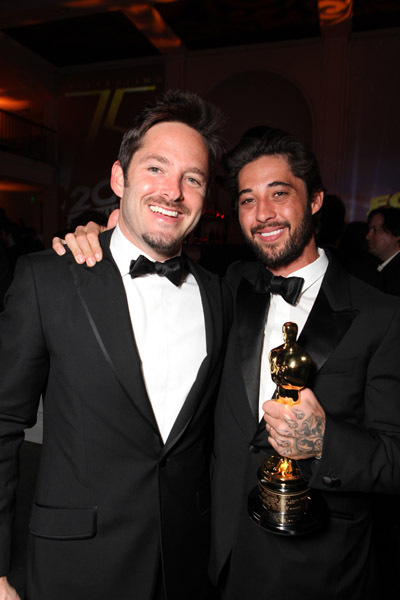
[0,233,231,600]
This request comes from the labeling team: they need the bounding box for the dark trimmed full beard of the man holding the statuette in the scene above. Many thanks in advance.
[242,202,314,269]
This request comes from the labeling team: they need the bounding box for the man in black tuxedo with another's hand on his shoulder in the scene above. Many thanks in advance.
[0,91,231,600]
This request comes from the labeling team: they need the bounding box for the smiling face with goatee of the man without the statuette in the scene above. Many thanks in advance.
[111,122,208,261]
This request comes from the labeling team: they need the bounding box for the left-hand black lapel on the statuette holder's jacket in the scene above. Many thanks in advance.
[236,267,269,421]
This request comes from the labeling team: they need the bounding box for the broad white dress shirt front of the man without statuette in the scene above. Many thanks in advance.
[110,226,206,442]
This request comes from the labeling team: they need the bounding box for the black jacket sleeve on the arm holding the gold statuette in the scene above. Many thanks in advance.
[305,302,400,493]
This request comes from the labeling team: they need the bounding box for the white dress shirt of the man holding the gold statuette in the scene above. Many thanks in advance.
[259,248,328,420]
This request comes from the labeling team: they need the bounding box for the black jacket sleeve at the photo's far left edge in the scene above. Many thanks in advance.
[0,257,48,575]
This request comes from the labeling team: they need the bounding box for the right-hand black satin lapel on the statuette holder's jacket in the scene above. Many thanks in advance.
[298,256,358,377]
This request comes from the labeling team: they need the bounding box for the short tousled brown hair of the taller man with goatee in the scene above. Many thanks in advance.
[118,90,225,195]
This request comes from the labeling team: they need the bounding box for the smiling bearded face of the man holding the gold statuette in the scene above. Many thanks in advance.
[238,156,323,277]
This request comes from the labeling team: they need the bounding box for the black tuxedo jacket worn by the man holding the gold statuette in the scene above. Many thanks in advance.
[211,253,400,600]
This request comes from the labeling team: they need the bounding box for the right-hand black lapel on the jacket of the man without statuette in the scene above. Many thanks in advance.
[162,261,216,455]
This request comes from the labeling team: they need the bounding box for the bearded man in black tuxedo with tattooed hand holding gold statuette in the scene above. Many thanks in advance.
[211,129,400,600]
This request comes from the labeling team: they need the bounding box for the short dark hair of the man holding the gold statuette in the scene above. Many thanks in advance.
[224,126,324,201]
